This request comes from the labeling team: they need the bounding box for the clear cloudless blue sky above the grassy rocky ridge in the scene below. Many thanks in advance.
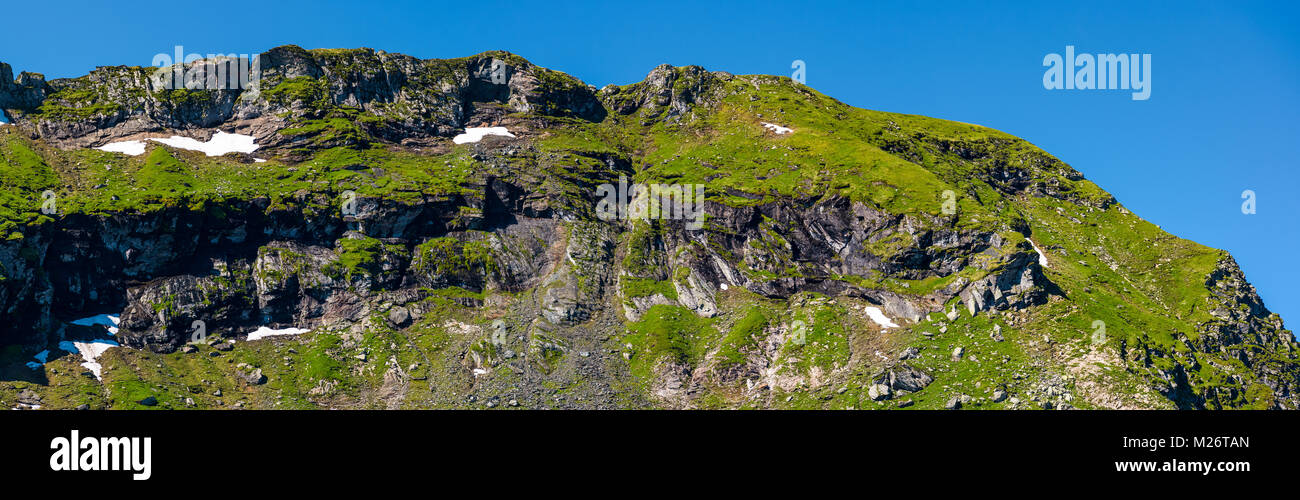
[0,0,1300,329]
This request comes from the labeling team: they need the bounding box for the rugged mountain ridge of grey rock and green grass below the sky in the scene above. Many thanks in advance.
[0,47,1300,408]
